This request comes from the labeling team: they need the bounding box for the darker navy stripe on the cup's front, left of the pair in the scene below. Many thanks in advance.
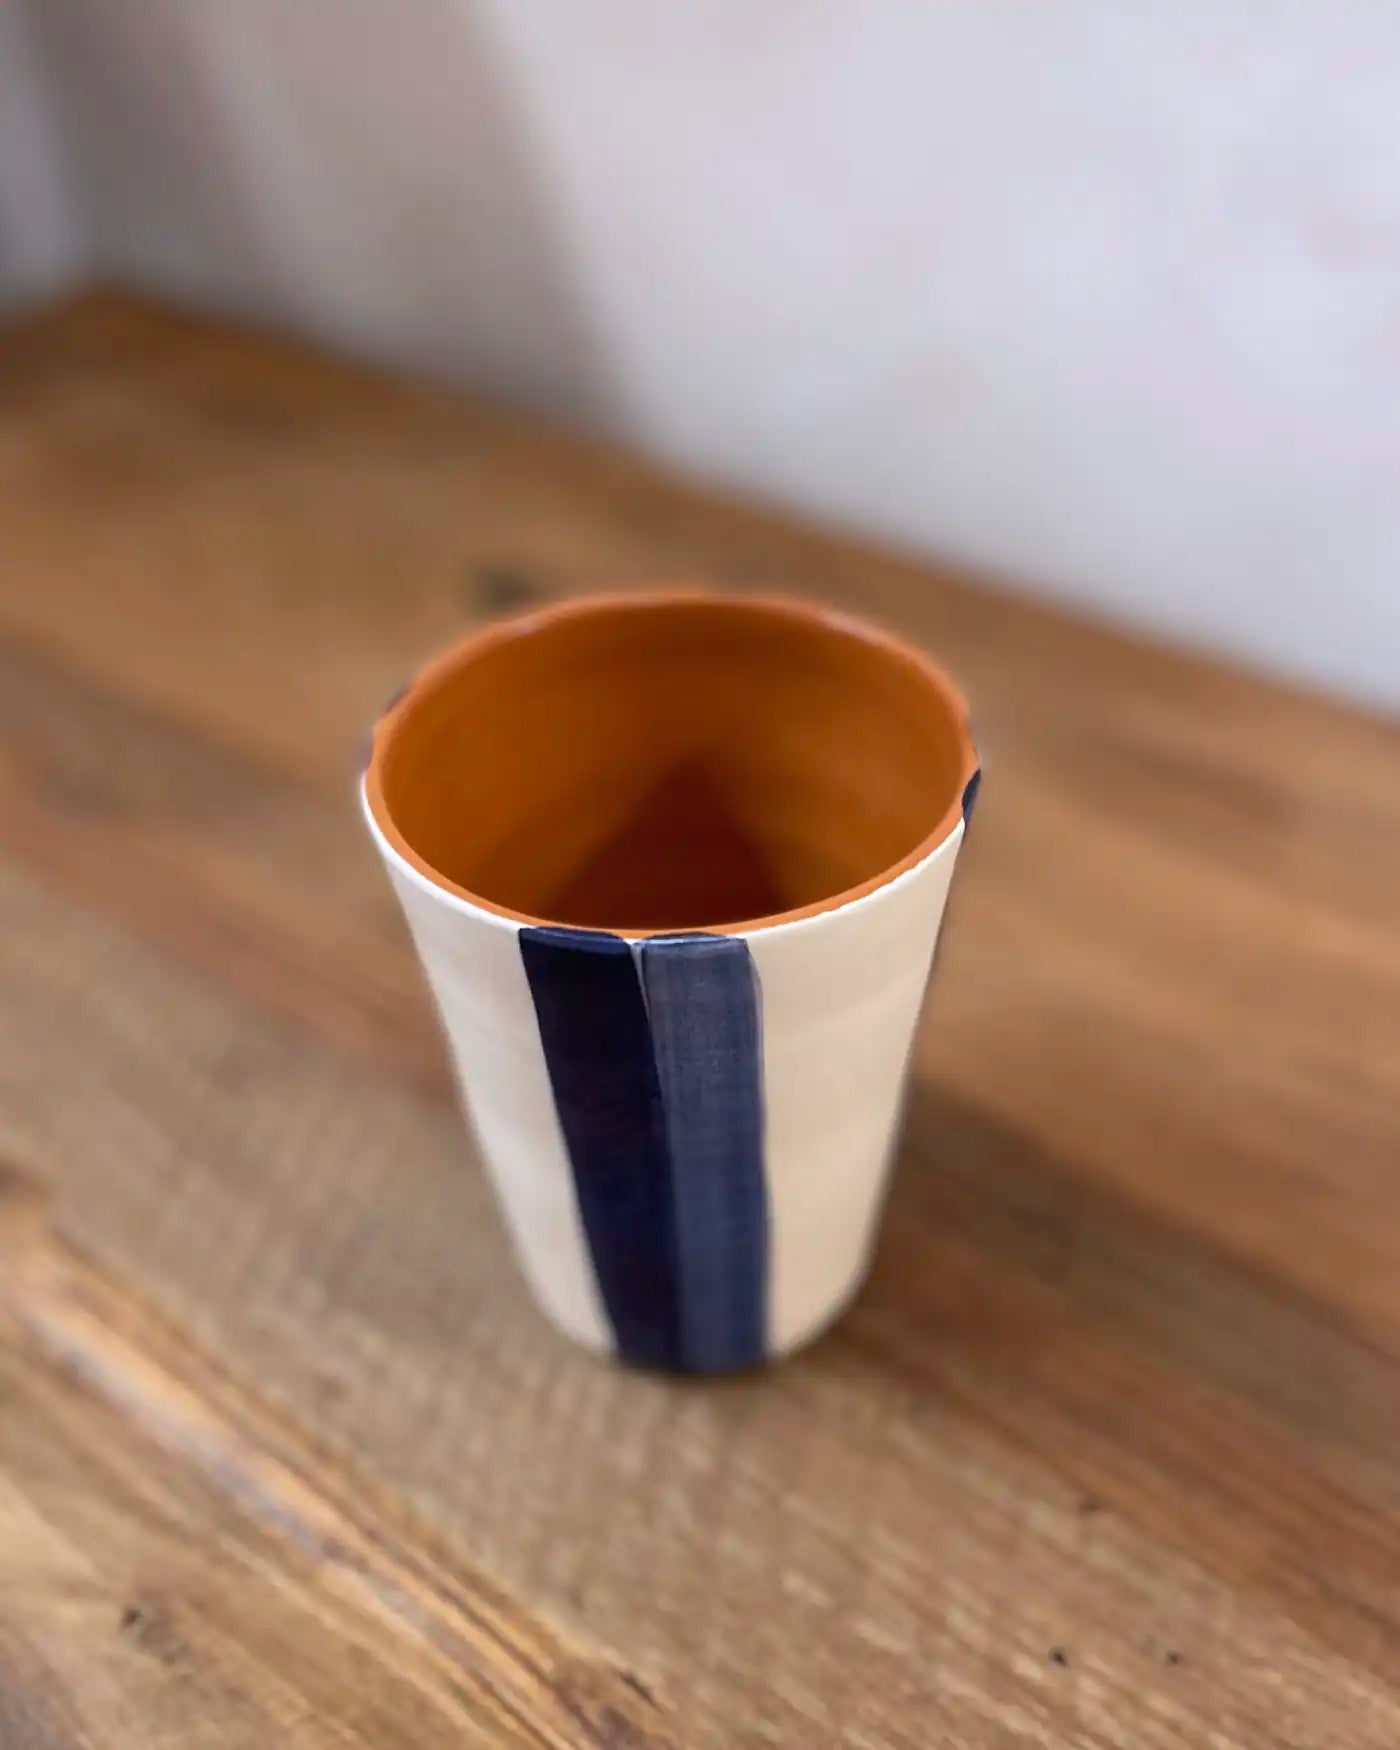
[520,928,684,1369]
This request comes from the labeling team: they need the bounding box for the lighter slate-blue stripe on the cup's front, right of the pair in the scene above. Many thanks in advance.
[641,936,768,1374]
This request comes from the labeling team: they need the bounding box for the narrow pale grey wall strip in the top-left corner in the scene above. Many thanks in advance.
[0,0,84,310]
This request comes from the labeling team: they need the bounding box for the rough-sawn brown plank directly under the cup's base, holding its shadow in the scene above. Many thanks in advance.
[0,854,1400,1750]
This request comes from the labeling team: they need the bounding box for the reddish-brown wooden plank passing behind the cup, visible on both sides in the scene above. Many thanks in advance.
[0,609,1400,1328]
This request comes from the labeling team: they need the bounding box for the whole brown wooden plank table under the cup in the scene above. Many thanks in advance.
[0,298,1400,1750]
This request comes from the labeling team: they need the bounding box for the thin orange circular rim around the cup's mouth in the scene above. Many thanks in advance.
[362,586,978,942]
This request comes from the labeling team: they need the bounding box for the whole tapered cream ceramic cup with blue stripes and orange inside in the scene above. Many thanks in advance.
[364,592,978,1372]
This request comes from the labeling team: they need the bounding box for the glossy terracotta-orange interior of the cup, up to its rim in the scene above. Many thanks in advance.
[366,592,975,935]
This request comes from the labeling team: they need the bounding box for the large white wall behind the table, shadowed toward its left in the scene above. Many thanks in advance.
[10,0,1400,705]
